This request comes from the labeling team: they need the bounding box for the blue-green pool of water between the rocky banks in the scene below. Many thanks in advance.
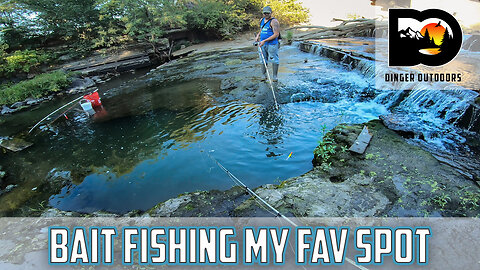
[0,47,386,213]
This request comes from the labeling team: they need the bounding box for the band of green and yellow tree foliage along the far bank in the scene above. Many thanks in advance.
[0,0,308,50]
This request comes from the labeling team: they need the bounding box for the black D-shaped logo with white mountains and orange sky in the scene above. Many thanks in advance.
[388,9,462,66]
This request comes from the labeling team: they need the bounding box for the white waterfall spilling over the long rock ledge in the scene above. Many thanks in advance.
[297,41,480,135]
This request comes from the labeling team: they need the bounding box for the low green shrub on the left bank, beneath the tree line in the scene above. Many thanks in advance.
[0,71,71,105]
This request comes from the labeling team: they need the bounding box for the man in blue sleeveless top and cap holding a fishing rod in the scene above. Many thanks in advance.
[256,6,280,82]
